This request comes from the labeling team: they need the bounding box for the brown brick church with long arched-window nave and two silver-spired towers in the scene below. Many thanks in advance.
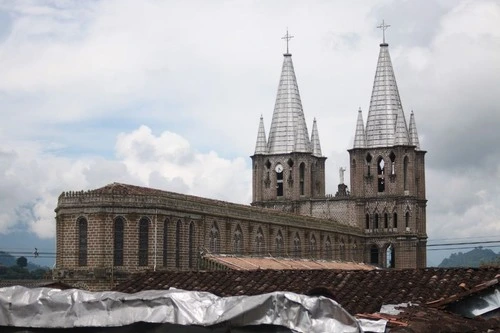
[54,37,427,289]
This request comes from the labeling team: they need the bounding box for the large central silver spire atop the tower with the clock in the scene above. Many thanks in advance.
[267,54,312,154]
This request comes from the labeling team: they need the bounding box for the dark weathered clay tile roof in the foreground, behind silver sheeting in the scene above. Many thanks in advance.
[115,267,500,314]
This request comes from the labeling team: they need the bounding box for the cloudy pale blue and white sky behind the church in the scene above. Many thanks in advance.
[0,0,500,265]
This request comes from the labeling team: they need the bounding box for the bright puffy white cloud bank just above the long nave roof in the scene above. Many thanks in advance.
[0,126,251,238]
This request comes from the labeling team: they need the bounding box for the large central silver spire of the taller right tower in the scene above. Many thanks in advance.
[366,43,408,148]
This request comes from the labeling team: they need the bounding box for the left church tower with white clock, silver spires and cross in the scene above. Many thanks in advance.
[251,32,326,211]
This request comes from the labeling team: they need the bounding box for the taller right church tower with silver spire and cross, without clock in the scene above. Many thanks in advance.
[349,23,427,268]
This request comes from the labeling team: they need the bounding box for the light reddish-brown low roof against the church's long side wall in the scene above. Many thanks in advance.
[204,254,376,271]
